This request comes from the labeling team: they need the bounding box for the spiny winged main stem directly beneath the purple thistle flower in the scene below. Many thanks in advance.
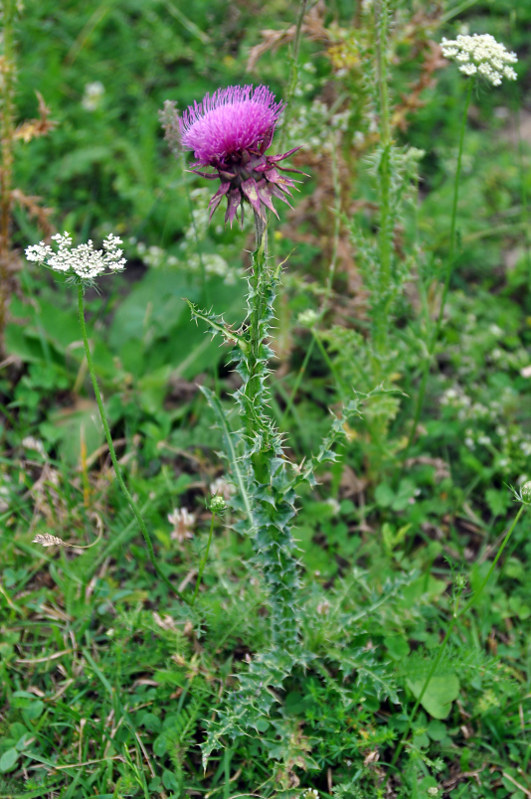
[236,216,299,649]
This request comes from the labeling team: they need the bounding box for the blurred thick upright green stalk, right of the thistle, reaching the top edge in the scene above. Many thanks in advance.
[374,0,392,360]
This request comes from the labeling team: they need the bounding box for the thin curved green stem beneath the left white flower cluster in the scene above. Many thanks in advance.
[77,281,190,604]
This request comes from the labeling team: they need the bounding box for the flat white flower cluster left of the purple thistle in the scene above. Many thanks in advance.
[26,232,126,280]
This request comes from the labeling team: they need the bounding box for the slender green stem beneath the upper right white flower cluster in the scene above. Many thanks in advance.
[404,80,472,454]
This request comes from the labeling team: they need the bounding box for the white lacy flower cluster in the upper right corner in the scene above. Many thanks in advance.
[441,33,518,86]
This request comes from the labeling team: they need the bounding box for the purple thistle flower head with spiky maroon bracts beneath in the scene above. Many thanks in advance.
[179,86,304,227]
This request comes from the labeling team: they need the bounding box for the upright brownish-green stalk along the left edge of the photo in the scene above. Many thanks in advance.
[0,0,16,353]
